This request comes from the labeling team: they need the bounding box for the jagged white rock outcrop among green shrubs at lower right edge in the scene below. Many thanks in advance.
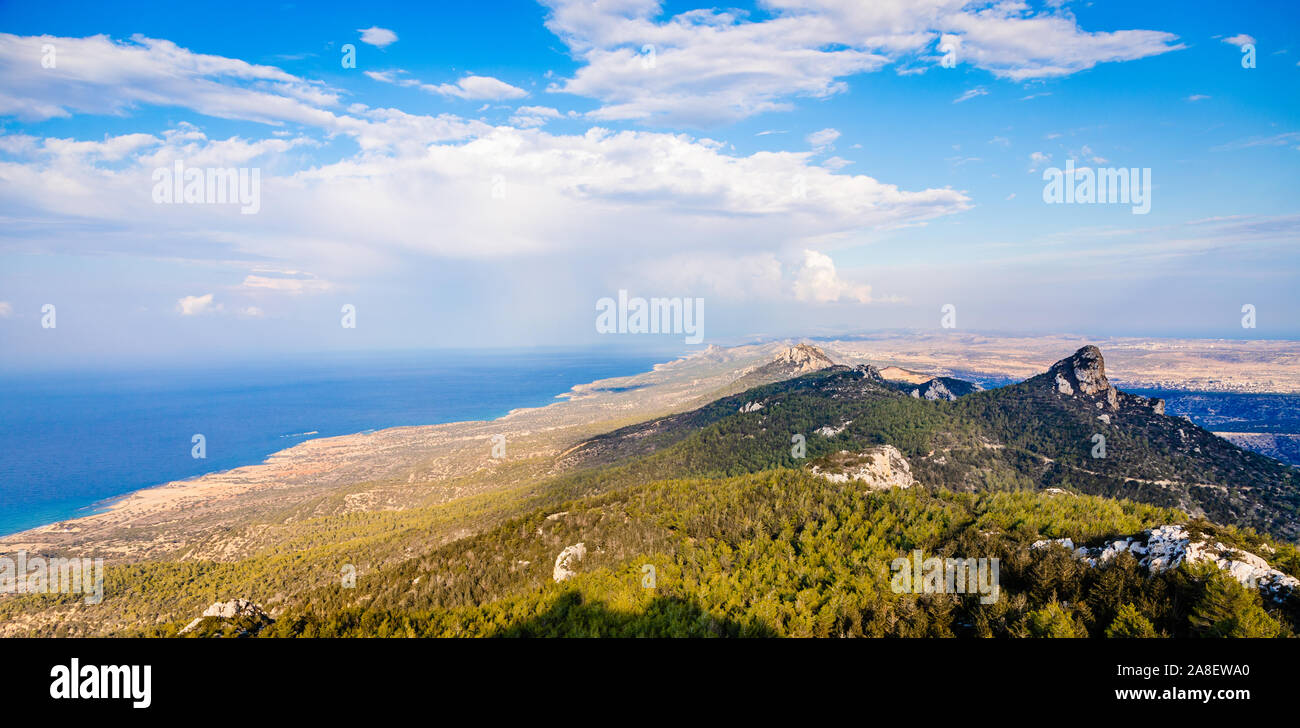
[1030,524,1300,601]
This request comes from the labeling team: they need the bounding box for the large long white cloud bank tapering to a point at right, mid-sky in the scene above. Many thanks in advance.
[0,118,970,271]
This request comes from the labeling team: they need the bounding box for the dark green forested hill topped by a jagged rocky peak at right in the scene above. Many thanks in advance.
[566,346,1300,540]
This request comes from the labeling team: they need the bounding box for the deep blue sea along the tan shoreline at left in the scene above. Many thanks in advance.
[0,350,671,536]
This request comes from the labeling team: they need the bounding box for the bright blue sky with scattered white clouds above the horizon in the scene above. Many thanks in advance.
[0,0,1300,368]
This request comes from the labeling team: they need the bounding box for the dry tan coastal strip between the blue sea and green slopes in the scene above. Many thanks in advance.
[0,343,780,558]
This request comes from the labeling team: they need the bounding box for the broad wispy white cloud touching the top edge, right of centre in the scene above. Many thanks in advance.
[542,0,1182,125]
